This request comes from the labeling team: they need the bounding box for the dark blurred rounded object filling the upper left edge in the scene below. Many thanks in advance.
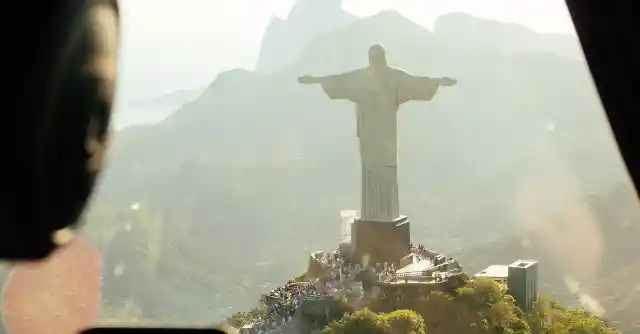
[5,0,119,260]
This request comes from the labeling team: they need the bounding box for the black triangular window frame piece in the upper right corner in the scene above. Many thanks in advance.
[565,0,640,194]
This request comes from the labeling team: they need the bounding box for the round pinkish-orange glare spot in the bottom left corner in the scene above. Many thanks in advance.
[2,237,101,334]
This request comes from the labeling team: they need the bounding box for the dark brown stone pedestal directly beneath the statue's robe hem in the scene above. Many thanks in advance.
[351,216,411,266]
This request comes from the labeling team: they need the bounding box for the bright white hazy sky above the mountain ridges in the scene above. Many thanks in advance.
[119,0,574,98]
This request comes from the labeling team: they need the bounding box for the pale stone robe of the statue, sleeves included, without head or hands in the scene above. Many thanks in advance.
[320,67,439,222]
